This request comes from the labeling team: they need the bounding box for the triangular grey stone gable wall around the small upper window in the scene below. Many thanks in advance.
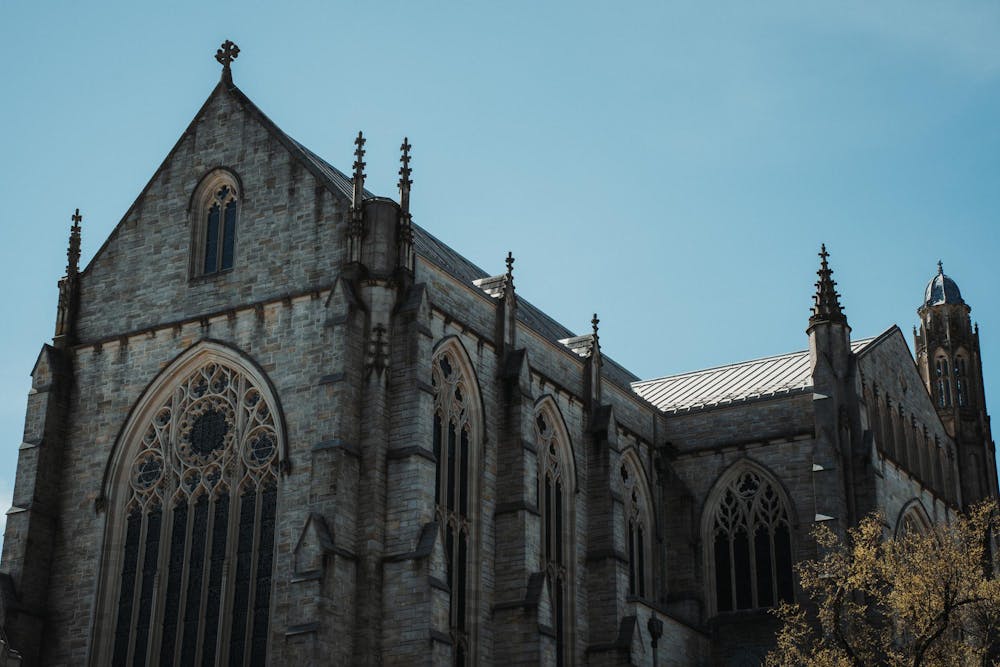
[78,83,350,342]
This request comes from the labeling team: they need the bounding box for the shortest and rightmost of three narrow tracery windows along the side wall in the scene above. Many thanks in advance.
[618,449,653,598]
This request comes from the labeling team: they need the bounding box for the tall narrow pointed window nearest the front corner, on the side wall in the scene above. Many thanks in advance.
[431,345,481,667]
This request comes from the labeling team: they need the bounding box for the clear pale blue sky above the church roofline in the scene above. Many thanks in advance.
[0,0,1000,532]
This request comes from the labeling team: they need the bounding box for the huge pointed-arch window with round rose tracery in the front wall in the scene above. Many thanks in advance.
[109,360,280,666]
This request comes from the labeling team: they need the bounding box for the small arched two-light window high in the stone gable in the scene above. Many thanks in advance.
[193,169,240,276]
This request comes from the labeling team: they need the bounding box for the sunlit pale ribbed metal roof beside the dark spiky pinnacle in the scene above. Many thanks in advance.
[632,338,877,413]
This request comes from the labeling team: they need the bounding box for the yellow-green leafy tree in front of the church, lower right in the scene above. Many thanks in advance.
[767,502,1000,667]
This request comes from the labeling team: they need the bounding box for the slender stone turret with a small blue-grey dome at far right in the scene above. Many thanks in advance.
[914,262,997,506]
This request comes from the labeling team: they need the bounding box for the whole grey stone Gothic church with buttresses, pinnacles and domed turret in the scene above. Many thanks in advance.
[0,42,997,665]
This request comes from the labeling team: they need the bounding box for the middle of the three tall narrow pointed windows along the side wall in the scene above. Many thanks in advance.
[535,399,576,665]
